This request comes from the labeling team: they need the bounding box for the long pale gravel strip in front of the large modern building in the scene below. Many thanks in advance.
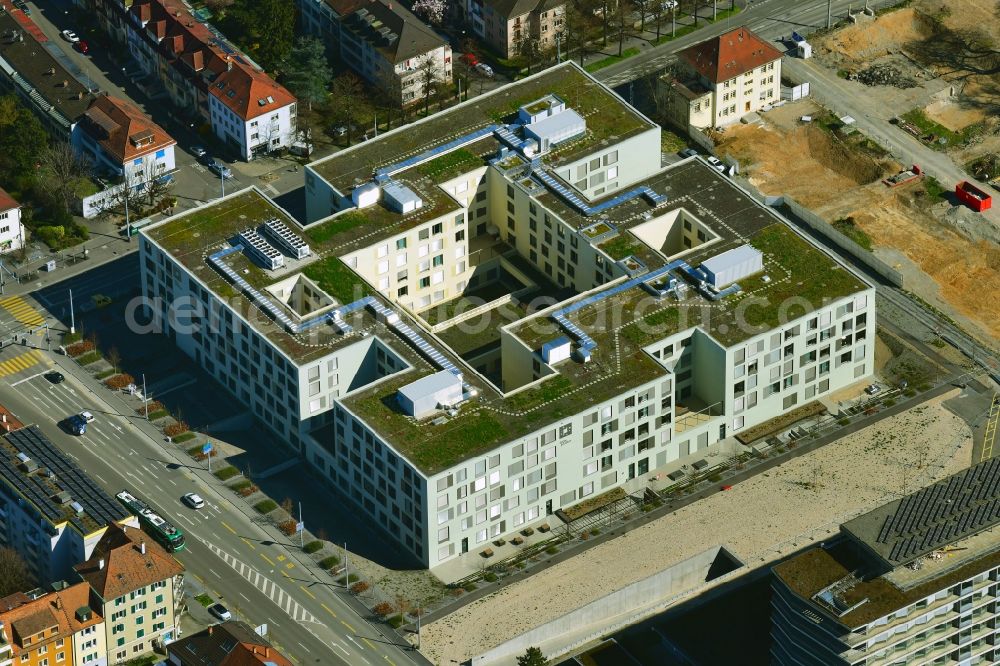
[421,389,972,664]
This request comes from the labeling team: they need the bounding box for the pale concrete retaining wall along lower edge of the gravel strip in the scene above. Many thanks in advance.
[469,546,744,666]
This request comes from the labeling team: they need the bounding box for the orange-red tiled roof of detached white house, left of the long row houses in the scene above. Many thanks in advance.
[84,95,177,164]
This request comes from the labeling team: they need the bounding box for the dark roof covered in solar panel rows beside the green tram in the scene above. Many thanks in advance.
[0,425,128,534]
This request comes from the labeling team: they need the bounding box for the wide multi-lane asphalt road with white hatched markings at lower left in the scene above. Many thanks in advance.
[0,338,426,666]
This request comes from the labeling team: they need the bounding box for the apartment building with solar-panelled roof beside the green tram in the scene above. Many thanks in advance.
[0,425,138,583]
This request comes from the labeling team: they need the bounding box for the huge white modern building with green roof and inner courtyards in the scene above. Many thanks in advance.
[140,63,875,566]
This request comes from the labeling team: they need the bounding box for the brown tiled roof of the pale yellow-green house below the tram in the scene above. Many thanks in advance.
[73,524,184,601]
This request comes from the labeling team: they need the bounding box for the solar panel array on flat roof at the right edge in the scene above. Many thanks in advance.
[876,458,1000,563]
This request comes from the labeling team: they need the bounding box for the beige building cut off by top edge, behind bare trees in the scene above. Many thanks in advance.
[464,0,566,58]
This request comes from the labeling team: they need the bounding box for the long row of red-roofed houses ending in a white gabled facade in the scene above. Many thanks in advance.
[87,0,296,161]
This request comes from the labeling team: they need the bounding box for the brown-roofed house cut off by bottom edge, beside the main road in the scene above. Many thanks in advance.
[167,620,292,666]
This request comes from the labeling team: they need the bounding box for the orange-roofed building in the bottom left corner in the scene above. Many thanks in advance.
[0,582,108,666]
